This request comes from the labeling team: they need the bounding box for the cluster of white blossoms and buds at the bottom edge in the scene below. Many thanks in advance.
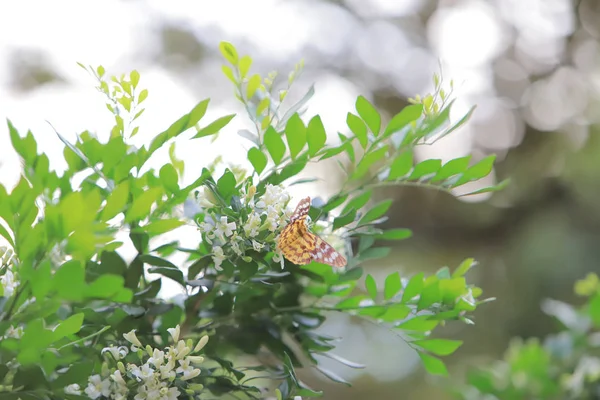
[75,325,208,400]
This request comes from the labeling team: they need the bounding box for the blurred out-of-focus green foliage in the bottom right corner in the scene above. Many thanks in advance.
[456,273,600,400]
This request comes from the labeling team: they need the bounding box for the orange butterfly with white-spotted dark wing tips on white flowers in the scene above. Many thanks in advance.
[277,197,346,267]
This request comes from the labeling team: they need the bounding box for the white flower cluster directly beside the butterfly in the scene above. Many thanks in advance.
[199,185,292,269]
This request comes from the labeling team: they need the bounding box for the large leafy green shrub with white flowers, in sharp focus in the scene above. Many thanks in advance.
[0,43,505,400]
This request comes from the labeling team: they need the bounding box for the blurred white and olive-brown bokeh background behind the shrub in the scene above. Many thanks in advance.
[0,0,600,400]
